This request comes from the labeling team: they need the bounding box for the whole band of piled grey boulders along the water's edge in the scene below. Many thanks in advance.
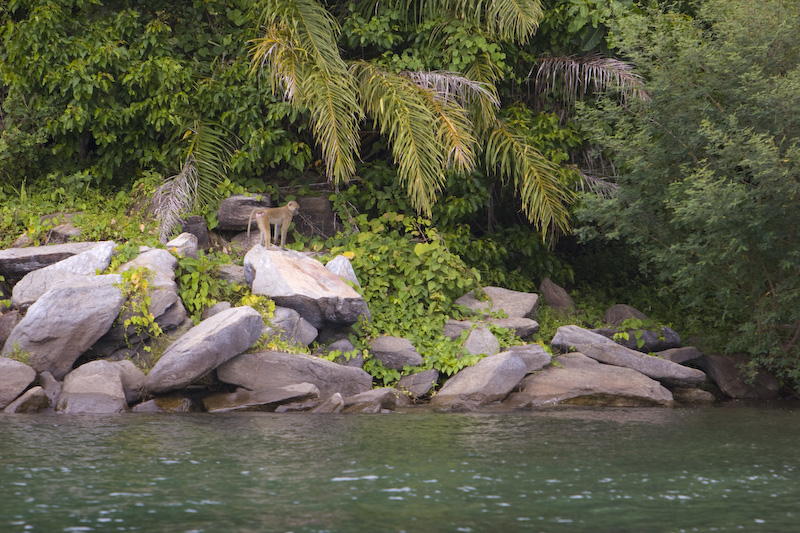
[0,214,779,414]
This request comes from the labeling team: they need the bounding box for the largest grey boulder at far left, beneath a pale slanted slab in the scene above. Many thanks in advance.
[2,276,125,379]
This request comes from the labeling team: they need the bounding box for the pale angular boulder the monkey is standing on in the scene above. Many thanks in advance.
[244,246,369,329]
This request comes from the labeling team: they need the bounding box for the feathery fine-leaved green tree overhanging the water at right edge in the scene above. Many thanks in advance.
[583,0,800,383]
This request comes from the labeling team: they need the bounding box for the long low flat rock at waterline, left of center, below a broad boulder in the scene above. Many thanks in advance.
[203,383,319,413]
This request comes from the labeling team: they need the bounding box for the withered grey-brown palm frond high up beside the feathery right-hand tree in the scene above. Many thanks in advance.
[528,54,650,103]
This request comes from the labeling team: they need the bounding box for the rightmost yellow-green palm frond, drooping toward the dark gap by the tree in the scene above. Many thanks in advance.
[485,121,574,237]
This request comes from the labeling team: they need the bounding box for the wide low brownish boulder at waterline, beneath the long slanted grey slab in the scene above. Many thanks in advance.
[505,353,674,408]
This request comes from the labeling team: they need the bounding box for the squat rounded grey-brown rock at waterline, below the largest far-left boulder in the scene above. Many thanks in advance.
[56,360,128,414]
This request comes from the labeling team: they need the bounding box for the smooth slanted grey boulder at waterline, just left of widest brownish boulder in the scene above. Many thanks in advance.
[431,352,527,409]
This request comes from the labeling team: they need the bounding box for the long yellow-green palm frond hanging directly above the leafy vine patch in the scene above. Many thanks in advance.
[352,61,445,214]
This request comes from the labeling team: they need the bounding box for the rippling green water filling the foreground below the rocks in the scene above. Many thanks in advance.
[0,407,800,533]
